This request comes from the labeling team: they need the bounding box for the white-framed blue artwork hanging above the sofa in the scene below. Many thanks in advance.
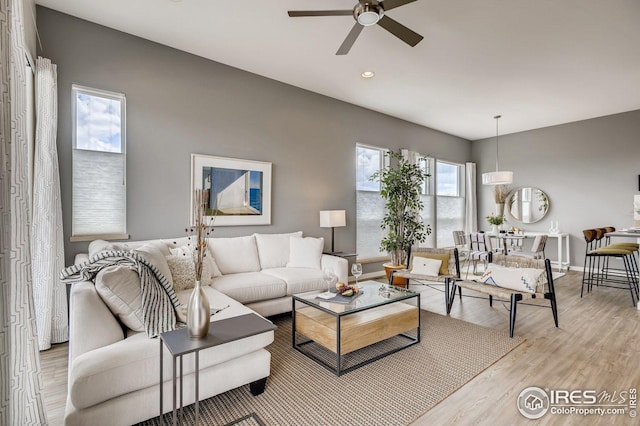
[191,154,271,226]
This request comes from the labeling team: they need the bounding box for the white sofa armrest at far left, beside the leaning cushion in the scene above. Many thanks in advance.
[69,281,124,365]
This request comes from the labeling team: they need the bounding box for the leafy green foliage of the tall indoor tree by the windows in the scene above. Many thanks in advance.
[371,152,431,267]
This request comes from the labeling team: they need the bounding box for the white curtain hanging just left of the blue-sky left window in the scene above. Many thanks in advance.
[31,58,69,351]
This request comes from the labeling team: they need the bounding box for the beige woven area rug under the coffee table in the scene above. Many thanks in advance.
[142,311,524,426]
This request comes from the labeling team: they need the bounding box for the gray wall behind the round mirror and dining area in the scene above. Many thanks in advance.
[472,110,640,266]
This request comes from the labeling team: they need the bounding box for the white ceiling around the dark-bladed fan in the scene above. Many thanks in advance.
[36,0,640,140]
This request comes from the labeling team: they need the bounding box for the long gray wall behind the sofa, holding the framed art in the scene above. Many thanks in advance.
[37,7,471,263]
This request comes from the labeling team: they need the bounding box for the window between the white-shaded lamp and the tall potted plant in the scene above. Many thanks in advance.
[356,144,388,260]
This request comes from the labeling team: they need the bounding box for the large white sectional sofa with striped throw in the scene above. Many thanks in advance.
[65,232,347,426]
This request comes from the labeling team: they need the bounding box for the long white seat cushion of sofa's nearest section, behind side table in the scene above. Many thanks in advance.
[69,287,273,409]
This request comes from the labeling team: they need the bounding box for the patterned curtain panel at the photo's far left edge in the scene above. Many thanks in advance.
[0,0,47,425]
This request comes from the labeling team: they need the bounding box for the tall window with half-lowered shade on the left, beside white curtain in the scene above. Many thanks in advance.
[71,84,128,241]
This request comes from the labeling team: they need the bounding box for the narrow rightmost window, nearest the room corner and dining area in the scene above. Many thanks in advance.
[435,160,465,247]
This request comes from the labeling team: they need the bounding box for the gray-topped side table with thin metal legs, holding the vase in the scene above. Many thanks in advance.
[158,314,277,426]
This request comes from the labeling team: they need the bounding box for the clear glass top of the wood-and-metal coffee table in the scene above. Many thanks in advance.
[293,281,419,315]
